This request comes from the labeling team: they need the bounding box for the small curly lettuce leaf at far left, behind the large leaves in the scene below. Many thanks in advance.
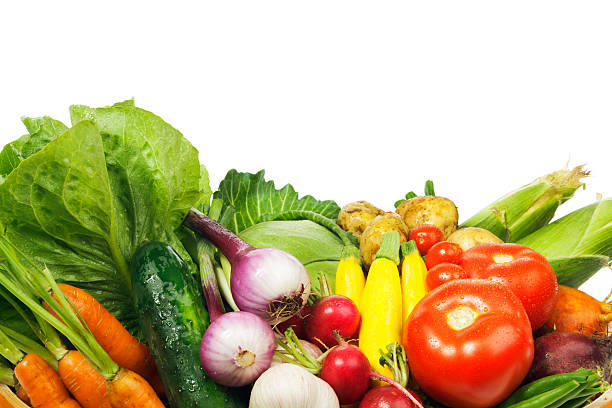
[0,116,68,179]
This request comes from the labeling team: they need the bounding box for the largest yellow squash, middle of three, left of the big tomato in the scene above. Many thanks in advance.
[359,231,402,377]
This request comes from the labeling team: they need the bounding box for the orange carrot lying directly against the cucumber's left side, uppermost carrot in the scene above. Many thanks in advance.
[45,283,160,391]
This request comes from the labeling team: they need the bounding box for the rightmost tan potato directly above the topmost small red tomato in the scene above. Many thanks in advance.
[395,196,459,238]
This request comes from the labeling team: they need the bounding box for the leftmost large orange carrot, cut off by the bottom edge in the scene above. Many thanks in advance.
[15,353,80,408]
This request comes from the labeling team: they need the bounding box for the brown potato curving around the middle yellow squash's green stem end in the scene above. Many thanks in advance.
[359,212,410,268]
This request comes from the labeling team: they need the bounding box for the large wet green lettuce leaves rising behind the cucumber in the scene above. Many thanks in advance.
[0,101,209,333]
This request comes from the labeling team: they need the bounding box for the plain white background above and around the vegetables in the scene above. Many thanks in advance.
[0,0,612,299]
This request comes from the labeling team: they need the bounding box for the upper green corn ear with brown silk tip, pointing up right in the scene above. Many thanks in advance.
[460,166,589,242]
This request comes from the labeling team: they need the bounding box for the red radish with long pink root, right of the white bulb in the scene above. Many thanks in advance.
[320,343,423,408]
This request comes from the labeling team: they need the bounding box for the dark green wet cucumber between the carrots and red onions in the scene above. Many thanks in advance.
[131,242,248,408]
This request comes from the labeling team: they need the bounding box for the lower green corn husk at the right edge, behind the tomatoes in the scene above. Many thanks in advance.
[518,198,612,288]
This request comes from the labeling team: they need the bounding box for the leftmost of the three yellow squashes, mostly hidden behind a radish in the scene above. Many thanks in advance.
[336,246,365,310]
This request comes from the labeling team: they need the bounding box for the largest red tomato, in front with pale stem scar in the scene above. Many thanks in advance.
[402,279,534,408]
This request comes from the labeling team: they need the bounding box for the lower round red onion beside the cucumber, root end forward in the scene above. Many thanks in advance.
[200,311,276,387]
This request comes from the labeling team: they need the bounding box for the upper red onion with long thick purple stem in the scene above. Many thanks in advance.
[185,209,310,325]
